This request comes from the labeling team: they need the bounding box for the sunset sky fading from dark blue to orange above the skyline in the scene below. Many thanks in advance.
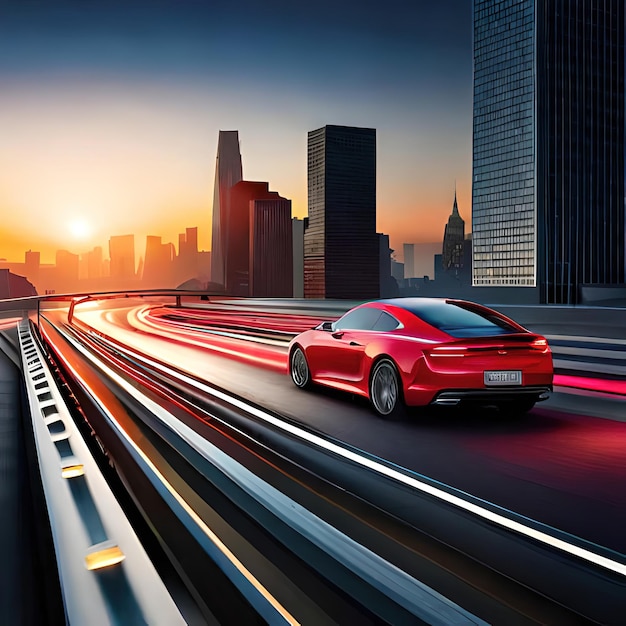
[0,0,472,263]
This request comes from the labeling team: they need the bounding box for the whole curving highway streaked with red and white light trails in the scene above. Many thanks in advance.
[1,294,626,623]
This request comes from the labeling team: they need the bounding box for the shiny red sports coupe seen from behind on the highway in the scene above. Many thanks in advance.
[289,298,553,417]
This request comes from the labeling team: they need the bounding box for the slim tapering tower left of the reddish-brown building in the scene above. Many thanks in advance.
[211,130,243,285]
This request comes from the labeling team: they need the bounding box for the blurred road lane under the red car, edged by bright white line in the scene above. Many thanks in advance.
[46,300,626,554]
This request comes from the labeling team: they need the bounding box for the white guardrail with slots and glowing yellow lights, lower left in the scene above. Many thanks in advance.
[18,320,185,626]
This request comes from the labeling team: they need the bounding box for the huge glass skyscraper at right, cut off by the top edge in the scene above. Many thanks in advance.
[472,0,624,303]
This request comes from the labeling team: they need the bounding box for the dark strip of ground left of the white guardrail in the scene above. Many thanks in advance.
[0,331,65,626]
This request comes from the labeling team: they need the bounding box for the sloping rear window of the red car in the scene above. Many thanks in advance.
[390,300,519,337]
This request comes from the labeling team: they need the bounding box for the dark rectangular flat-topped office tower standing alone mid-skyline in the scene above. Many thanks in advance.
[304,126,379,300]
